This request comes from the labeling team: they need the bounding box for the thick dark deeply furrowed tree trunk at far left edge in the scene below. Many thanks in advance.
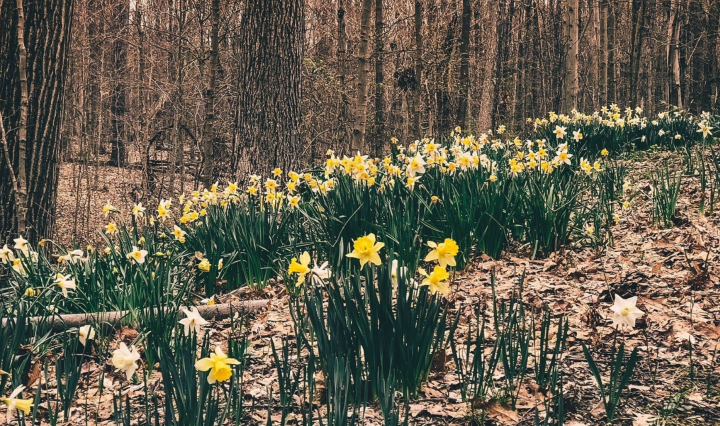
[0,0,74,241]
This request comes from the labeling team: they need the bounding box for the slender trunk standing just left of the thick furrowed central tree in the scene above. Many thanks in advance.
[202,0,220,188]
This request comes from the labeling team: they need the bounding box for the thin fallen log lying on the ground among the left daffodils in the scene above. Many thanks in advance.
[2,299,270,331]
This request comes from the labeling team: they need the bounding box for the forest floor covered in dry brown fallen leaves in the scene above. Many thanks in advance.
[57,154,720,426]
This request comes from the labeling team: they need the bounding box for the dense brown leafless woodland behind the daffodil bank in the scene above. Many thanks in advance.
[0,0,720,242]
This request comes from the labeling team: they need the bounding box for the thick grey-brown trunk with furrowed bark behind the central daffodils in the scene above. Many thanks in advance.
[237,0,305,175]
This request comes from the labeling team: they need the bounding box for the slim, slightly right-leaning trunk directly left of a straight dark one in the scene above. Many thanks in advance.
[351,0,373,152]
